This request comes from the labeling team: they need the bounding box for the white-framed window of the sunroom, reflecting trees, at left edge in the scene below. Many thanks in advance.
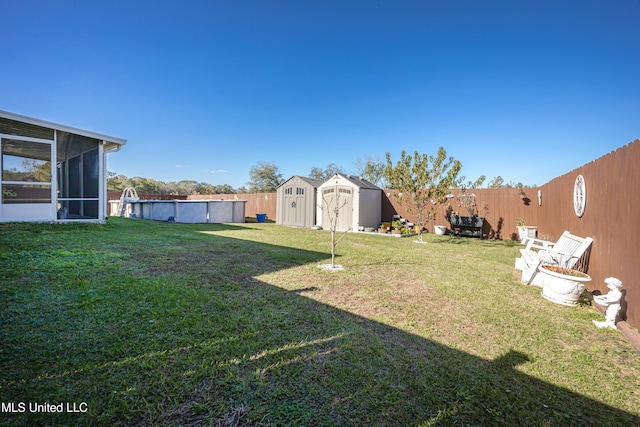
[2,138,51,204]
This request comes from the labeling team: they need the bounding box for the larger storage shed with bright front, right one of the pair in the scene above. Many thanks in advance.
[316,173,382,231]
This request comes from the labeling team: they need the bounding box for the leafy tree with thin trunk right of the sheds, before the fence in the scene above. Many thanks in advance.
[385,147,462,242]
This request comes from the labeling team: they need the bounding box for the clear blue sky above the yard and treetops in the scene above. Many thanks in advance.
[0,0,640,188]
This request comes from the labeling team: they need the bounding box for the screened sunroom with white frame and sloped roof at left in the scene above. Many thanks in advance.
[0,111,126,222]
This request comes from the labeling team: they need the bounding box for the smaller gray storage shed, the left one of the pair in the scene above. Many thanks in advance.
[276,175,322,227]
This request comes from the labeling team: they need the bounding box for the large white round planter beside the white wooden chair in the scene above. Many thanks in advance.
[538,264,591,306]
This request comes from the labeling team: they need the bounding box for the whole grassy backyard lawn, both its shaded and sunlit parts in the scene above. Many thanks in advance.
[0,218,640,426]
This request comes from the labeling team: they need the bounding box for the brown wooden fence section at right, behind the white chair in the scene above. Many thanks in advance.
[536,139,640,328]
